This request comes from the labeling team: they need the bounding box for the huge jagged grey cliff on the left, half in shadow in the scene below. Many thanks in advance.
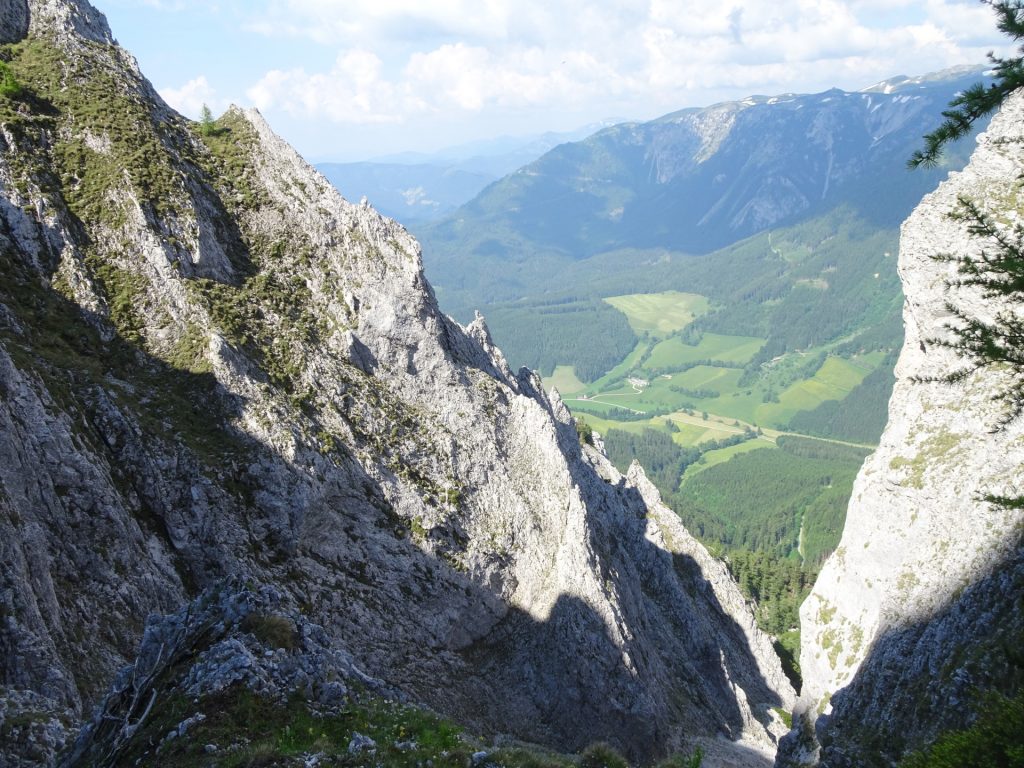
[0,0,792,765]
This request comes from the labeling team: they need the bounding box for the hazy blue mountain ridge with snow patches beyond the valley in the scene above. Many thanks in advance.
[417,67,984,313]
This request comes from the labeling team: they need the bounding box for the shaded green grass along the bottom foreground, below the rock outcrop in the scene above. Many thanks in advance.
[118,685,701,768]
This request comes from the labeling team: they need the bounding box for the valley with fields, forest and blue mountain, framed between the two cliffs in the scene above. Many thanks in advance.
[405,68,984,651]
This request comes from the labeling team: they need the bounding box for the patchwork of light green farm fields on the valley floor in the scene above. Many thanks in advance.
[545,291,885,438]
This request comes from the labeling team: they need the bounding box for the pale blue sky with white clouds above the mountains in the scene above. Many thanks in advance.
[99,0,1010,162]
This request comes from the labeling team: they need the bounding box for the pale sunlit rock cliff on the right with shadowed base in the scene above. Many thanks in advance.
[779,88,1024,766]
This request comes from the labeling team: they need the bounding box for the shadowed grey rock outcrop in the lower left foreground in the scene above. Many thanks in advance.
[60,583,401,766]
